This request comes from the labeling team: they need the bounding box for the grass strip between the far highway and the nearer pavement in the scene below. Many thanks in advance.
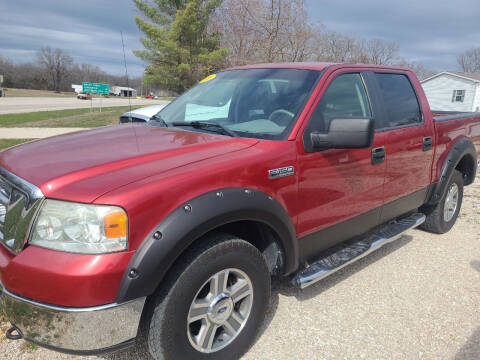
[0,106,138,127]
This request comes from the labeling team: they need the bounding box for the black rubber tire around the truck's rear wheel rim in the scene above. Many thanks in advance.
[420,170,463,234]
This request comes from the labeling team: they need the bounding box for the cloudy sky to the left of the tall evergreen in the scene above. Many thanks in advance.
[0,0,144,76]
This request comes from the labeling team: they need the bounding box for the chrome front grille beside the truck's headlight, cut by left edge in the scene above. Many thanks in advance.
[0,167,43,253]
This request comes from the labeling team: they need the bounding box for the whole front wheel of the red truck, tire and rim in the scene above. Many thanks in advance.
[140,234,270,360]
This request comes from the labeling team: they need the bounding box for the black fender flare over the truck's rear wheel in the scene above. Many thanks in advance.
[427,138,477,205]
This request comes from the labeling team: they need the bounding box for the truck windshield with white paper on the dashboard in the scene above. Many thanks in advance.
[149,69,320,140]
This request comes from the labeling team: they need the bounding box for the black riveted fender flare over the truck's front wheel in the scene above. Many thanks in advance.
[115,188,298,303]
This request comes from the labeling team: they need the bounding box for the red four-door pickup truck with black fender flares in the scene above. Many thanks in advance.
[0,63,480,359]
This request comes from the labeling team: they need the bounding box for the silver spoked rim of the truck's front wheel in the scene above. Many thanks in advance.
[187,268,253,353]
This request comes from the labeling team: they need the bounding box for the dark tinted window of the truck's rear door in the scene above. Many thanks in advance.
[375,73,422,128]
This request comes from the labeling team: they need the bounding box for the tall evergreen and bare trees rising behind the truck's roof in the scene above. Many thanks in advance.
[133,0,480,92]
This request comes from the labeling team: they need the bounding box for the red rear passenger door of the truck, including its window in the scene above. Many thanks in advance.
[370,72,433,222]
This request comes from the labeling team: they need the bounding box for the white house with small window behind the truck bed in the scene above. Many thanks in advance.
[422,71,480,112]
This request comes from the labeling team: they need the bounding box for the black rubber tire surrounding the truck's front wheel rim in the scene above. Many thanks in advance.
[136,234,270,360]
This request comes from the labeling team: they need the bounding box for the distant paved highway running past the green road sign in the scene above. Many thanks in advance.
[0,97,168,114]
